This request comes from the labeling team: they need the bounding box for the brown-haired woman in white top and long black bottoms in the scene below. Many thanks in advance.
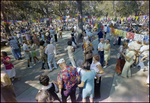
[90,54,104,98]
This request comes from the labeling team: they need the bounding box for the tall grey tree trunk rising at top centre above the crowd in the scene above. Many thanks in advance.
[76,1,83,38]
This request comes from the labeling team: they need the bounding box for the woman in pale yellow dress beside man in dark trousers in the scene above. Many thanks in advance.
[103,39,110,68]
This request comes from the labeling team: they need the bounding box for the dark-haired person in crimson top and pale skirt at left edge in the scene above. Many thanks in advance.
[1,51,16,81]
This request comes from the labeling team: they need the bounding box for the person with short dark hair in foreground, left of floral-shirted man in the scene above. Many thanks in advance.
[36,75,61,102]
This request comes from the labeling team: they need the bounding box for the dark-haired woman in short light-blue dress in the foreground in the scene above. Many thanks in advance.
[78,62,99,102]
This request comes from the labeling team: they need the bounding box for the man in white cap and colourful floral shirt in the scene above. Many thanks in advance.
[57,58,80,102]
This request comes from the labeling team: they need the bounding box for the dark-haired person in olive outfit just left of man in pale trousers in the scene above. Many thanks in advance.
[40,40,49,69]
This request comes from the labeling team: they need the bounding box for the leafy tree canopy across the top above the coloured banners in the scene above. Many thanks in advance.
[1,0,149,20]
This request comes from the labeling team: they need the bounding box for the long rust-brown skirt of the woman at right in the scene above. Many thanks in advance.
[115,58,125,74]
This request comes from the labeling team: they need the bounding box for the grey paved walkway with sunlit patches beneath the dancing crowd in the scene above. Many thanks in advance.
[1,32,149,102]
